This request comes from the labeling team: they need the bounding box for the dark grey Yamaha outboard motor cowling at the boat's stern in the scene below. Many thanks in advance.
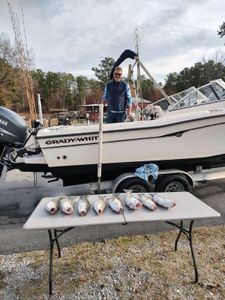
[0,106,27,148]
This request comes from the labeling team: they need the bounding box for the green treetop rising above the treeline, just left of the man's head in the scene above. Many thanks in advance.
[91,57,115,88]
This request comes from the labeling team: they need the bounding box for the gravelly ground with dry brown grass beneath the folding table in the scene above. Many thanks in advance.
[0,226,225,300]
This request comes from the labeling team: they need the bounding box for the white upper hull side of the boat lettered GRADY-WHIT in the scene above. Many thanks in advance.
[35,113,225,167]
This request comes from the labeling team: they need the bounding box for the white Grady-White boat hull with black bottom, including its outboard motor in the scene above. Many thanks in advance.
[0,98,225,185]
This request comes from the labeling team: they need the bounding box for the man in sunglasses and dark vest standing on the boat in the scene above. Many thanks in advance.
[102,67,132,123]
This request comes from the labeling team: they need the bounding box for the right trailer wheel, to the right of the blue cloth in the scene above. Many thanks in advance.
[156,175,191,192]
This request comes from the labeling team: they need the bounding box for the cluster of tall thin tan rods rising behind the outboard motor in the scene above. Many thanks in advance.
[7,0,37,123]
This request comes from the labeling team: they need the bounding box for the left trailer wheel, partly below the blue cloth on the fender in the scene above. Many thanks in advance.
[116,178,153,193]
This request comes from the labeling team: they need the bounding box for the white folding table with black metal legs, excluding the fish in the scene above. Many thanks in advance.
[23,192,220,295]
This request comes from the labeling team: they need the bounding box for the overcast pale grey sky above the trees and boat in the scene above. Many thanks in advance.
[0,0,225,81]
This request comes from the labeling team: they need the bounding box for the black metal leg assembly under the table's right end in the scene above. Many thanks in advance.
[166,220,198,282]
